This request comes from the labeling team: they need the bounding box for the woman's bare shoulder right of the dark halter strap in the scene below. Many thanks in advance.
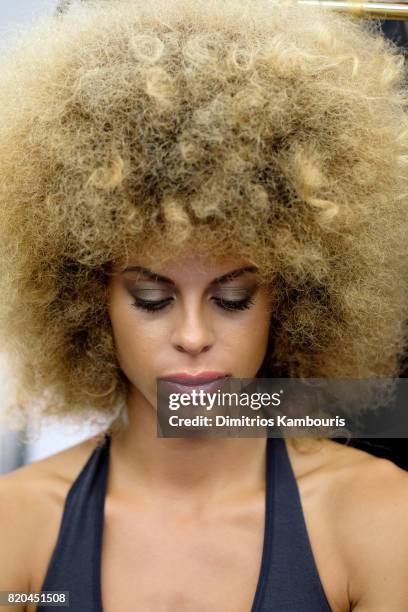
[291,440,408,612]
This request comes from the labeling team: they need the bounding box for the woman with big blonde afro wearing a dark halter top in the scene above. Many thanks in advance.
[0,0,408,612]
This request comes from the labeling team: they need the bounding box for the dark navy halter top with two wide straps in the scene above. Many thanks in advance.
[37,434,331,612]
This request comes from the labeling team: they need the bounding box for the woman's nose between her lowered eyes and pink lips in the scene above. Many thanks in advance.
[172,304,215,355]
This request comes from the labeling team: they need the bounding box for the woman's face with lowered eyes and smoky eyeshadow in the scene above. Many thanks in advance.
[108,252,272,407]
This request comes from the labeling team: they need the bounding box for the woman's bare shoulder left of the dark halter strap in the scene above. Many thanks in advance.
[0,436,100,600]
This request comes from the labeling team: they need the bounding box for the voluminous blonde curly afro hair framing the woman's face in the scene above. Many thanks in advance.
[0,0,408,430]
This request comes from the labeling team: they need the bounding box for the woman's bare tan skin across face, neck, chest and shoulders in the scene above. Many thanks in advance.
[0,252,408,612]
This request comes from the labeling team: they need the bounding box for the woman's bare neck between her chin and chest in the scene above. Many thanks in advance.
[107,392,267,509]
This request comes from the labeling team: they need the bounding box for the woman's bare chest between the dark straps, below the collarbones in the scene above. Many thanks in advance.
[101,502,264,612]
